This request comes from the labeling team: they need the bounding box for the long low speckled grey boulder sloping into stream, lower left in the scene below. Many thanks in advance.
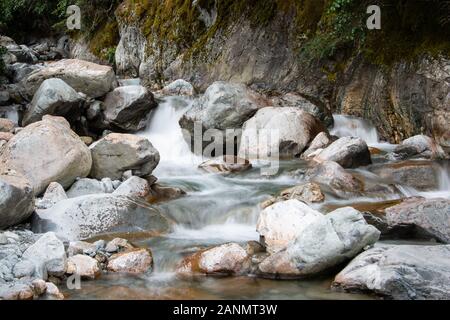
[32,194,169,240]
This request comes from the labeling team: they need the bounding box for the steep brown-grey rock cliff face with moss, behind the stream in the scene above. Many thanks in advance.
[72,0,450,147]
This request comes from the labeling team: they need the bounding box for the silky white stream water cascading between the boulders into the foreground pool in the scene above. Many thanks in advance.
[64,97,450,299]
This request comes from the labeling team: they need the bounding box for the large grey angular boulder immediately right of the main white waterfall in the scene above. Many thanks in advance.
[180,81,269,148]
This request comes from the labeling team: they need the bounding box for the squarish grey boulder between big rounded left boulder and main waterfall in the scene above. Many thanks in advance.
[90,133,160,179]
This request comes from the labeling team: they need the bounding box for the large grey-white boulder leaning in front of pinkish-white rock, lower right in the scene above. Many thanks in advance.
[258,206,380,278]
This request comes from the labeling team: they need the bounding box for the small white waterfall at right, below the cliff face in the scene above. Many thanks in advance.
[330,114,379,145]
